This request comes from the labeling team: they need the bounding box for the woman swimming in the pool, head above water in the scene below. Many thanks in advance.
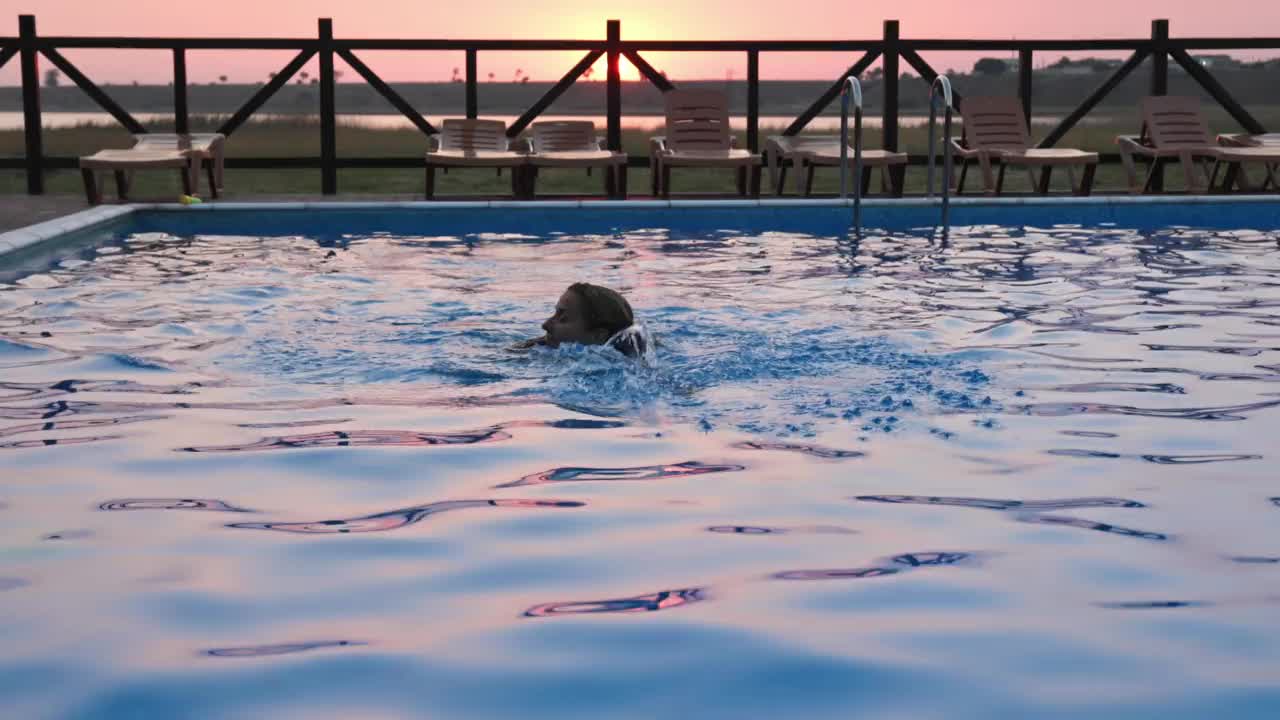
[516,283,645,357]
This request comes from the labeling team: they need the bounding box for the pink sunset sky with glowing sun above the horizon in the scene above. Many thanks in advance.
[0,0,1280,85]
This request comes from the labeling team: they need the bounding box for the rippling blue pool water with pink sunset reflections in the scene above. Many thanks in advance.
[0,204,1280,719]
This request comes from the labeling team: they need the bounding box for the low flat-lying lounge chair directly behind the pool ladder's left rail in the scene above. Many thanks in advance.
[764,135,908,197]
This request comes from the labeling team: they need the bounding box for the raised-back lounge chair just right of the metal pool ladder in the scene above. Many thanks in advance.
[951,96,1098,195]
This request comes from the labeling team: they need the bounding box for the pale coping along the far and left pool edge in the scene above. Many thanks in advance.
[0,195,1280,259]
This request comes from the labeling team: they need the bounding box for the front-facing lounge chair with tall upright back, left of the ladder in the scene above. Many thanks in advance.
[649,90,762,197]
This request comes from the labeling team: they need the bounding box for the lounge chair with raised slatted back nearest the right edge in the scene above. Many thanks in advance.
[1116,95,1280,193]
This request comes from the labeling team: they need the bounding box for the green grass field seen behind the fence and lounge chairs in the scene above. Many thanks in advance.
[0,108,1280,200]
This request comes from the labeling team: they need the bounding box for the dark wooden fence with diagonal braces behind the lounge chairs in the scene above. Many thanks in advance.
[0,15,1280,195]
